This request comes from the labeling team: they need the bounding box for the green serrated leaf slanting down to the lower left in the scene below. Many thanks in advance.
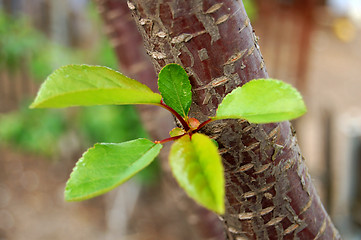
[65,139,162,201]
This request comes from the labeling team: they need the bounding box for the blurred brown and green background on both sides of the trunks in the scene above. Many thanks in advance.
[0,0,361,240]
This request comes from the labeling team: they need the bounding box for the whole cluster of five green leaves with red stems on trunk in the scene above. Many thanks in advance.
[31,64,306,214]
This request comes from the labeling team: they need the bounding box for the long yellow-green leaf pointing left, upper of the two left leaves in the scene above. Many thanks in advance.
[30,65,161,108]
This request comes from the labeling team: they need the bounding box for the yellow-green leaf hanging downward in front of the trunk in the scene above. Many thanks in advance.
[169,133,225,214]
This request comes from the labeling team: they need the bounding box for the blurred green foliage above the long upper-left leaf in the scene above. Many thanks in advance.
[0,7,118,81]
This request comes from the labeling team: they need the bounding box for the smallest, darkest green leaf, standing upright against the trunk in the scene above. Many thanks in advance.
[158,63,192,118]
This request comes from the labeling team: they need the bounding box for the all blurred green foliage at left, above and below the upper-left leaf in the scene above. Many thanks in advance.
[0,4,159,183]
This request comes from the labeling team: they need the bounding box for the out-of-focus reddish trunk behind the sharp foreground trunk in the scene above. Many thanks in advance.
[96,0,224,240]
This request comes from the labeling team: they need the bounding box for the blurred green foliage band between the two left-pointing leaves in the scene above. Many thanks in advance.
[0,104,147,156]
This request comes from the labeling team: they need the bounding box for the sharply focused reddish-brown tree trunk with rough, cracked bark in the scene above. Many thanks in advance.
[128,0,340,239]
